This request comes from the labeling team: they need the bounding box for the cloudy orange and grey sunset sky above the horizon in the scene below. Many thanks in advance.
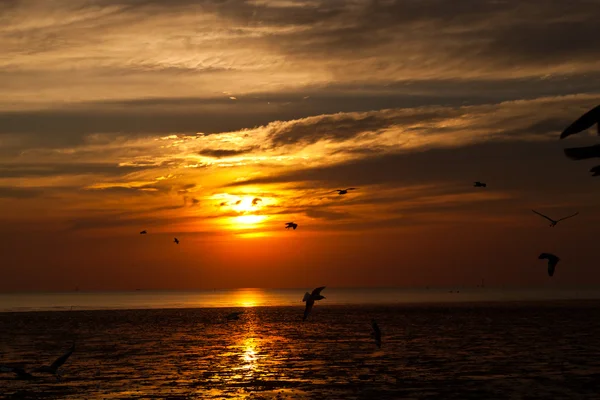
[0,0,600,291]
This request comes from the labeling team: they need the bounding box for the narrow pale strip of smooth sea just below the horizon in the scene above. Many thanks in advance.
[0,287,600,312]
